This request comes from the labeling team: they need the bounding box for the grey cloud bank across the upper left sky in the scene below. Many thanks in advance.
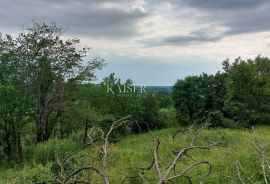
[0,0,149,38]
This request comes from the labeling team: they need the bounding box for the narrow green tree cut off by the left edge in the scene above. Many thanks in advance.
[0,35,32,161]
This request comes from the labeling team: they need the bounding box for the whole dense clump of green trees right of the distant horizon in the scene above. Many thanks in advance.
[173,56,270,127]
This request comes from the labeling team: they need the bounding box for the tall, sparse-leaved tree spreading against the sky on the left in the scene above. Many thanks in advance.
[16,23,103,142]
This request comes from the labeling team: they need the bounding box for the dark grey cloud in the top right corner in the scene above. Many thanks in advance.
[170,0,270,36]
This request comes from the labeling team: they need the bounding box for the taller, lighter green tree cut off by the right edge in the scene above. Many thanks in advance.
[225,56,270,126]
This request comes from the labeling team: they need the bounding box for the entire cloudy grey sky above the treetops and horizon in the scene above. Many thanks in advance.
[0,0,270,86]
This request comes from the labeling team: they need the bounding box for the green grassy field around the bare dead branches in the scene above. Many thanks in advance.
[0,127,270,184]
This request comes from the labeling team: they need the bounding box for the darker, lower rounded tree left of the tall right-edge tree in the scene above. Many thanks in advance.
[173,72,226,125]
